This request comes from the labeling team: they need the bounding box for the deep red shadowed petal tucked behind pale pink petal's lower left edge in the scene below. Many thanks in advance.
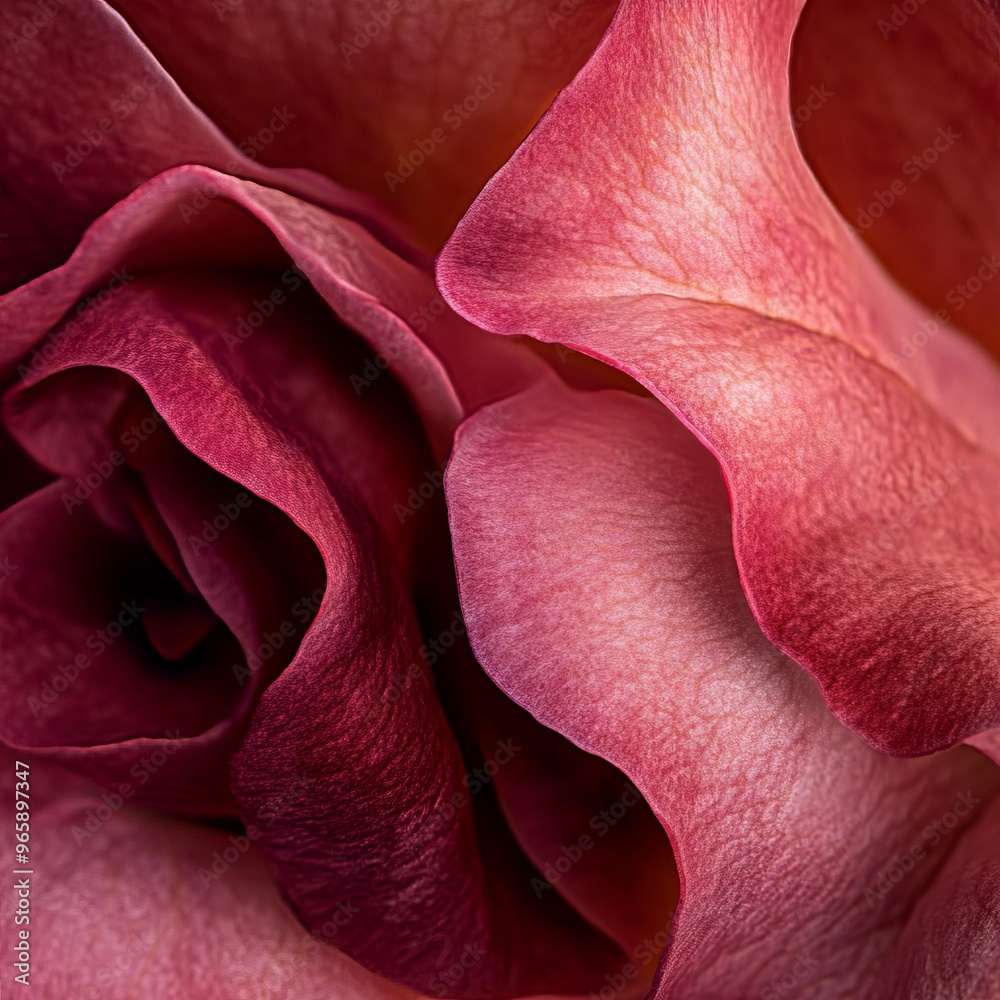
[436,640,678,960]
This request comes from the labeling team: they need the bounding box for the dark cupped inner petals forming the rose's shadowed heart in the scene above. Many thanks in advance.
[0,356,324,813]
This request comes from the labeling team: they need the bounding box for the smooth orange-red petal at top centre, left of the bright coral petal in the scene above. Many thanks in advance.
[115,0,615,247]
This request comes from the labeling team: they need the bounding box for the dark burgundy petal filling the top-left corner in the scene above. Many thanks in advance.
[0,0,405,290]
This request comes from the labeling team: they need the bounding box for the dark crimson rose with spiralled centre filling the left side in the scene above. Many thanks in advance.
[0,5,696,997]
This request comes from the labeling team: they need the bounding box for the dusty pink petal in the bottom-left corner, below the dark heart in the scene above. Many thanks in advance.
[0,754,416,1000]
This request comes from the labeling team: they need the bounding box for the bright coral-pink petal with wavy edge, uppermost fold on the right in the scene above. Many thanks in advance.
[438,0,1000,754]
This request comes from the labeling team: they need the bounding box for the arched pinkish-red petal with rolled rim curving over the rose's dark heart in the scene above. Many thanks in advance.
[0,167,546,463]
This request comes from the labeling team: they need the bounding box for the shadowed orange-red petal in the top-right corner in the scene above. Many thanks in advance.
[791,0,1000,357]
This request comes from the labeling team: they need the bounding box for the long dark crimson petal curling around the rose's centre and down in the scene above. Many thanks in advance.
[1,250,620,997]
